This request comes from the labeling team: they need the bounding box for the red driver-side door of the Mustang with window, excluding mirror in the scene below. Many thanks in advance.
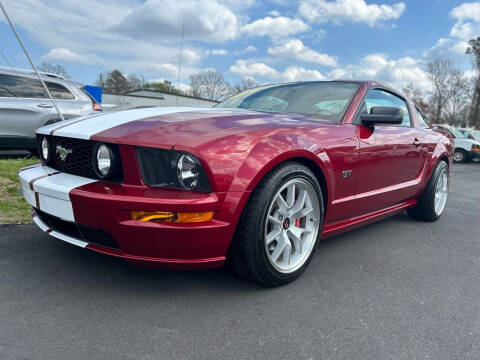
[355,88,426,214]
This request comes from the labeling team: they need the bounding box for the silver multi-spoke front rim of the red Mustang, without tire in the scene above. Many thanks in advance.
[264,178,320,273]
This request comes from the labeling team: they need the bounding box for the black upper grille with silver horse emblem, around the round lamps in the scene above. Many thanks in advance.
[41,136,123,182]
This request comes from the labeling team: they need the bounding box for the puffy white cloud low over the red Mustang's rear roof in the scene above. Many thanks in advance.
[328,54,431,90]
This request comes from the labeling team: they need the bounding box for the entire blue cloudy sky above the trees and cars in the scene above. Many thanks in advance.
[0,0,480,93]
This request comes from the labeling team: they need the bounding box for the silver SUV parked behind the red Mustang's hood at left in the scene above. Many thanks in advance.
[0,68,102,151]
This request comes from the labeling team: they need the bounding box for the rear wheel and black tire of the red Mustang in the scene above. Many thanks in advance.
[407,160,450,221]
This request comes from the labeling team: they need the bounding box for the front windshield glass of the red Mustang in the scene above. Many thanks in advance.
[215,81,359,122]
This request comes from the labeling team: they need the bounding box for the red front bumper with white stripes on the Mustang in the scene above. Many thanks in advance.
[19,164,238,268]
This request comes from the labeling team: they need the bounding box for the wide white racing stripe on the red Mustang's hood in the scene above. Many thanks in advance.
[37,107,215,140]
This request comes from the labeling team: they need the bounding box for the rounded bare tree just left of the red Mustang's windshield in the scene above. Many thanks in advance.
[190,69,230,100]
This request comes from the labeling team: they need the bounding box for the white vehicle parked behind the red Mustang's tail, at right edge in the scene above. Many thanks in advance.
[432,124,480,163]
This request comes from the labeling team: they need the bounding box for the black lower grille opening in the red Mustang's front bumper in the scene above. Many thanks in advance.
[35,209,120,250]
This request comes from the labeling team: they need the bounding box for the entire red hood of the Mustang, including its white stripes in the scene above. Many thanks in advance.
[37,108,318,147]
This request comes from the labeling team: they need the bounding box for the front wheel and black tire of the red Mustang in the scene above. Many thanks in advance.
[229,162,324,286]
